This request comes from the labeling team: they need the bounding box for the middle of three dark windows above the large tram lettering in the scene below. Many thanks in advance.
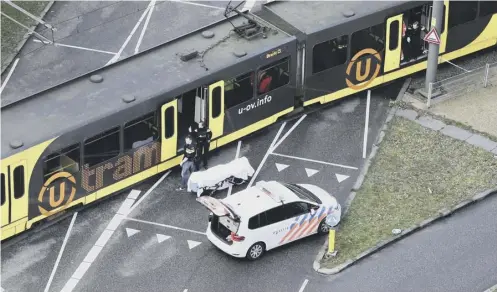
[84,127,120,167]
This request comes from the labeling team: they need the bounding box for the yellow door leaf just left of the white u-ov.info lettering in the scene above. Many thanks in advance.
[208,80,224,149]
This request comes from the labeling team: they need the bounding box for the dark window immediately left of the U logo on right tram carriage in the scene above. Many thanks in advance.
[312,35,349,74]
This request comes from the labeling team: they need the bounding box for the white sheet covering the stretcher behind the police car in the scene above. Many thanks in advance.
[188,157,255,194]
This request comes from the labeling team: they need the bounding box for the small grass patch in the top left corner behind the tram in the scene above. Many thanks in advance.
[0,1,50,66]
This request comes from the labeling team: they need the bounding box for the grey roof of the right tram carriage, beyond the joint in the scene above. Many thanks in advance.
[266,1,405,34]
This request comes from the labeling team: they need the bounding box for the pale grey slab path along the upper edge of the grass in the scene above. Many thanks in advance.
[395,109,497,156]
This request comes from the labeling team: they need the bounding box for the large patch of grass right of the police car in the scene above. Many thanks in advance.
[321,117,497,268]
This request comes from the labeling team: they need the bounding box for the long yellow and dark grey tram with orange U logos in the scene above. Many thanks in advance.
[1,1,497,240]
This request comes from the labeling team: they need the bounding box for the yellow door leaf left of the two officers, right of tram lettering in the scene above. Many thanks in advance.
[161,99,178,161]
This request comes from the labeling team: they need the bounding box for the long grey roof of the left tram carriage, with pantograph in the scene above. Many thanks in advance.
[1,16,293,158]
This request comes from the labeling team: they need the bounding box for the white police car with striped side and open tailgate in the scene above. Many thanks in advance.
[197,181,342,260]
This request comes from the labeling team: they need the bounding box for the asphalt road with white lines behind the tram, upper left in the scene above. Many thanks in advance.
[1,1,244,104]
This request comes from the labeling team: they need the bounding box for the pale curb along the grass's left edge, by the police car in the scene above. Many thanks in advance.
[312,78,412,275]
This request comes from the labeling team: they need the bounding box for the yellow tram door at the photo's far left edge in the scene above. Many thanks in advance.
[1,160,28,227]
